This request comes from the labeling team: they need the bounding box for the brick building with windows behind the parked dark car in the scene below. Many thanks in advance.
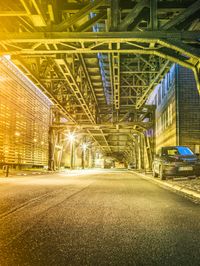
[148,64,200,154]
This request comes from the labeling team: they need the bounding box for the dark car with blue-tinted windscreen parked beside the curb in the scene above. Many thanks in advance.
[152,146,200,180]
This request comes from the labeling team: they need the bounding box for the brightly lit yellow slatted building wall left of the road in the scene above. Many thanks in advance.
[0,57,51,167]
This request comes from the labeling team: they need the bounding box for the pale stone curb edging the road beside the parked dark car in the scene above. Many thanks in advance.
[136,172,200,200]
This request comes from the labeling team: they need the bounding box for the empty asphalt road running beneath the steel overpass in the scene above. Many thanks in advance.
[0,171,200,266]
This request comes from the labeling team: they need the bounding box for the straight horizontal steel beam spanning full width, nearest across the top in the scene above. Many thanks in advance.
[0,30,200,44]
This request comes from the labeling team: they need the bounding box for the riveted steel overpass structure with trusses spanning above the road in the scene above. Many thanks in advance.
[0,0,200,167]
